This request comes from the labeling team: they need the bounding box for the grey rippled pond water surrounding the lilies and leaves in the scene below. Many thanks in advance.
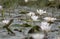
[0,2,60,39]
